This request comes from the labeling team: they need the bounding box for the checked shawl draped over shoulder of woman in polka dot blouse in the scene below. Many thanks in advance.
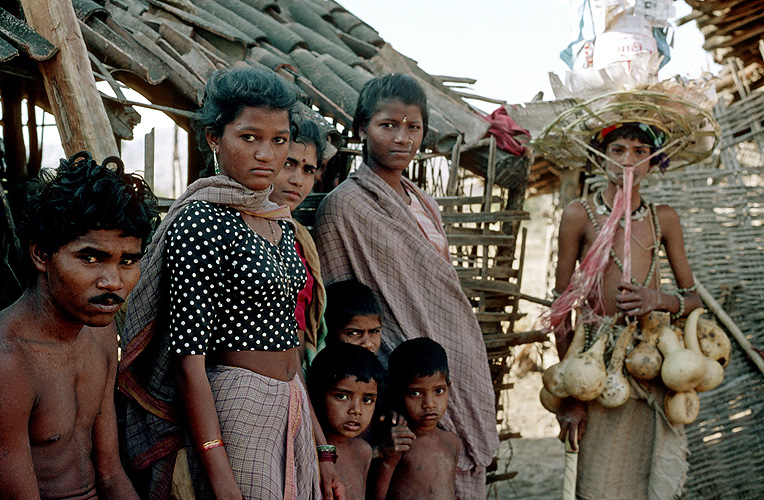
[117,175,292,499]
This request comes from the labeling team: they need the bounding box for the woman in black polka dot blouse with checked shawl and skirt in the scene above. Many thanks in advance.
[119,68,341,500]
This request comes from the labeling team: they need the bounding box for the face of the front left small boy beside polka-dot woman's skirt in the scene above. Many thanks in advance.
[324,377,377,438]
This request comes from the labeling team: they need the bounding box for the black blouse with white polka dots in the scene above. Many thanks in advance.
[164,202,306,354]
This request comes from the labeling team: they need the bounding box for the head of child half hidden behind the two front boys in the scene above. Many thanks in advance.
[324,279,382,354]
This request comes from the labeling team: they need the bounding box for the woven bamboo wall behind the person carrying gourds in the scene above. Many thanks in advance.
[642,96,764,500]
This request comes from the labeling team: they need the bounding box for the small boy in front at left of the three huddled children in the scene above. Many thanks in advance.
[308,343,384,500]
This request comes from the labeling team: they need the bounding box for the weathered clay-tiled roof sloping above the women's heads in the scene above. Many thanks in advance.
[0,0,532,188]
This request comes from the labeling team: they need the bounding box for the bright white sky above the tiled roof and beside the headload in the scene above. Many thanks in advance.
[337,0,713,109]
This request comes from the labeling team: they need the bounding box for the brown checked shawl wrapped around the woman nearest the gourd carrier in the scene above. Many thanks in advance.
[314,165,499,500]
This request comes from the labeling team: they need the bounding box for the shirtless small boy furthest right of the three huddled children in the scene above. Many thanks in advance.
[370,338,461,500]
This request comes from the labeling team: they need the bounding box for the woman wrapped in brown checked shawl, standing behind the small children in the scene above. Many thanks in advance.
[314,74,499,500]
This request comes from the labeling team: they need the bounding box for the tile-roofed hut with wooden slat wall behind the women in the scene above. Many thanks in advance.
[0,0,545,486]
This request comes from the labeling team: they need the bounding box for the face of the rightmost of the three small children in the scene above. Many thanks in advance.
[403,373,448,429]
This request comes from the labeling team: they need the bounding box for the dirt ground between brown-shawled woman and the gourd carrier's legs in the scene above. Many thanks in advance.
[488,372,565,500]
